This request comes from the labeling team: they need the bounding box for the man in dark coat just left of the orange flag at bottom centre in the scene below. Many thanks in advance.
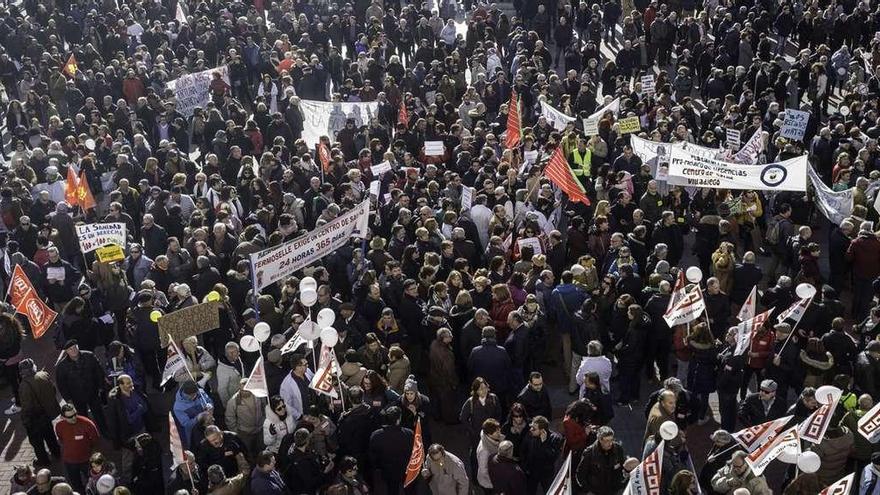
[370,406,413,494]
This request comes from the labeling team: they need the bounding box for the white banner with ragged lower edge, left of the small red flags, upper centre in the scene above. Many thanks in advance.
[300,100,379,148]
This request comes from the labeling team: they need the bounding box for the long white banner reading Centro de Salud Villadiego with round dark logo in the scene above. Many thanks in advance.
[667,147,808,191]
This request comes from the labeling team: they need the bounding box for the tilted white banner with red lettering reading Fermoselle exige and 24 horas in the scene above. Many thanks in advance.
[250,199,370,291]
